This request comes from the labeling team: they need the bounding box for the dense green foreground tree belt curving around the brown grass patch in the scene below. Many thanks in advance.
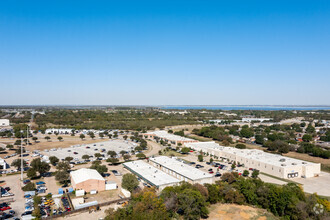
[106,173,330,220]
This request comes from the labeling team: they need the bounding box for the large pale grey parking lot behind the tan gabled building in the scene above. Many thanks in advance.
[41,140,137,159]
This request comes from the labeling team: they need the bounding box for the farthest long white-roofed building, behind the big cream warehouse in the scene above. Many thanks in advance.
[143,131,198,145]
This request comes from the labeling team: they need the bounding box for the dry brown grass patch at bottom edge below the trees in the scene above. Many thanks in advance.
[208,204,278,220]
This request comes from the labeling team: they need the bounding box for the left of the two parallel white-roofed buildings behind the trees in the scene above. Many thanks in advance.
[123,160,180,191]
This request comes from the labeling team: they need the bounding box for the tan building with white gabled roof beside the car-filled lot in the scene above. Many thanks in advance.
[70,168,105,192]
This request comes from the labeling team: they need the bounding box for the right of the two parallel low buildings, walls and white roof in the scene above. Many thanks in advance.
[149,156,214,184]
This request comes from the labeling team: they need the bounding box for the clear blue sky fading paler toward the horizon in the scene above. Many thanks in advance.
[0,0,330,105]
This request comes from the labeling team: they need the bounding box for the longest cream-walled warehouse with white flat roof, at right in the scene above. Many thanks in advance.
[185,142,321,179]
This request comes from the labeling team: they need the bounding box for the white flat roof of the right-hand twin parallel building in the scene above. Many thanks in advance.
[149,156,213,181]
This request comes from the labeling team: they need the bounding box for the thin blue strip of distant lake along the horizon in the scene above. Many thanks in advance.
[161,105,330,111]
